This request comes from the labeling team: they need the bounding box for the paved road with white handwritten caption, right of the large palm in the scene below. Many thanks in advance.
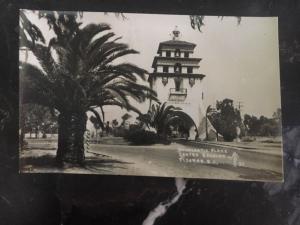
[89,141,282,181]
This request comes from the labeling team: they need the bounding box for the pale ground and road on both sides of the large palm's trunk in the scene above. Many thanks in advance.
[21,138,282,182]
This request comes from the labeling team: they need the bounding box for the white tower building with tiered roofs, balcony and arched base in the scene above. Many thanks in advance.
[149,27,211,139]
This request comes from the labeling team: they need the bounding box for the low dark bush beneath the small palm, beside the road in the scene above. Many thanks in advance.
[124,129,169,145]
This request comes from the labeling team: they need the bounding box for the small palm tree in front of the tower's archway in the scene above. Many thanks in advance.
[138,102,196,139]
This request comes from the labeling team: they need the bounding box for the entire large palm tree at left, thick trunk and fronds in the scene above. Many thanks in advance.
[20,13,156,163]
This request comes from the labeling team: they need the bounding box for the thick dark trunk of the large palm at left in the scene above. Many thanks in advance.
[56,112,87,164]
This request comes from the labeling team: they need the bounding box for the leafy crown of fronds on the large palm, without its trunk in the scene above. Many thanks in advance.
[21,12,158,118]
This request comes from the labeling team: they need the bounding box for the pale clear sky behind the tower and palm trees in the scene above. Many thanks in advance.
[21,11,281,123]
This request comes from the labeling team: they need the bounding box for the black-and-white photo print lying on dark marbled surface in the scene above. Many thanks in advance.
[19,9,283,182]
